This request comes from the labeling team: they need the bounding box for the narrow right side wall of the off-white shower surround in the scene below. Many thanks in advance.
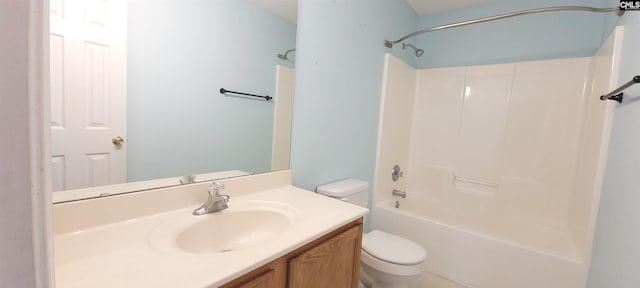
[569,26,624,256]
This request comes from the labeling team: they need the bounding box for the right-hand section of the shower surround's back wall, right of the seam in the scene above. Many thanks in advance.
[500,58,590,227]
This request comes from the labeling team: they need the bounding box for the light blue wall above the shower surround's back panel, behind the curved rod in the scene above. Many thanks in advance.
[415,0,617,68]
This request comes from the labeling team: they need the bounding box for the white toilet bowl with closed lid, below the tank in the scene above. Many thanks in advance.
[360,230,427,288]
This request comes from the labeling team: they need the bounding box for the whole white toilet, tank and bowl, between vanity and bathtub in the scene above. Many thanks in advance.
[316,179,427,288]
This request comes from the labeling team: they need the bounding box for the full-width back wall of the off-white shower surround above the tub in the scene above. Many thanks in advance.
[407,58,590,228]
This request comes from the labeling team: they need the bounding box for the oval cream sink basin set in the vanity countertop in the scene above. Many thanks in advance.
[176,210,289,253]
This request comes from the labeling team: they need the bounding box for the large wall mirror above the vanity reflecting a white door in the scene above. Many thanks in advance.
[50,0,297,202]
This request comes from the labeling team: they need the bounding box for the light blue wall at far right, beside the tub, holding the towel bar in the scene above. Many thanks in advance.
[588,12,640,288]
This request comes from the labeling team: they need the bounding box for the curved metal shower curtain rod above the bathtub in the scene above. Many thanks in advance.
[384,6,624,48]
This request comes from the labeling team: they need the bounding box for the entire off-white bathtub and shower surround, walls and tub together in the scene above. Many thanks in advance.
[372,27,620,288]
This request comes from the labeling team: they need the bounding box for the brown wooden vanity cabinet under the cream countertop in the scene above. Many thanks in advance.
[222,219,362,288]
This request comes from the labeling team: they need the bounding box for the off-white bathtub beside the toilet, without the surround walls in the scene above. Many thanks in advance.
[372,198,588,288]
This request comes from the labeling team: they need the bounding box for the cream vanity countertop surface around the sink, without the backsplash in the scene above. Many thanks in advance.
[54,177,368,288]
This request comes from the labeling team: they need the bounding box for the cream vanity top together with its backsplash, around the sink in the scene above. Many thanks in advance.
[53,170,367,288]
